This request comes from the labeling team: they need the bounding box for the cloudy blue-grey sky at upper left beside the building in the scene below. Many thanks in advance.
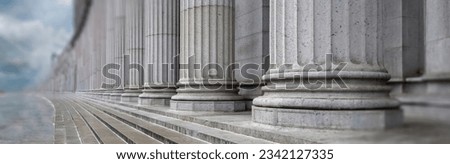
[0,0,73,92]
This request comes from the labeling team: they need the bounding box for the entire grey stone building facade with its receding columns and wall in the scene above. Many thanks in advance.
[43,0,450,130]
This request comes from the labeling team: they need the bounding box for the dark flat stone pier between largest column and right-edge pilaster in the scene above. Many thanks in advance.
[383,0,424,96]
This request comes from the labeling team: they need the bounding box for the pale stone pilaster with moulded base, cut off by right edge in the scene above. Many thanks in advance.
[400,0,450,125]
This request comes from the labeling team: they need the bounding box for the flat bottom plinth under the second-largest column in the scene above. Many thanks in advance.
[170,100,246,112]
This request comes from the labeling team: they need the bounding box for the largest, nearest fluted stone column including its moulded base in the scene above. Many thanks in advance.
[252,0,403,129]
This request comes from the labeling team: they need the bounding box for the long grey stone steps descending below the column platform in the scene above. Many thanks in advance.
[49,95,274,144]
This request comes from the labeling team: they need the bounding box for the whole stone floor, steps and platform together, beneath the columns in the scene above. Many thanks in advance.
[47,94,450,144]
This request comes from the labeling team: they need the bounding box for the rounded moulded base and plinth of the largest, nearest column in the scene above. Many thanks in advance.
[252,71,403,130]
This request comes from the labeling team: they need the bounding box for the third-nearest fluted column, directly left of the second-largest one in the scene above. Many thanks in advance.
[139,0,180,106]
